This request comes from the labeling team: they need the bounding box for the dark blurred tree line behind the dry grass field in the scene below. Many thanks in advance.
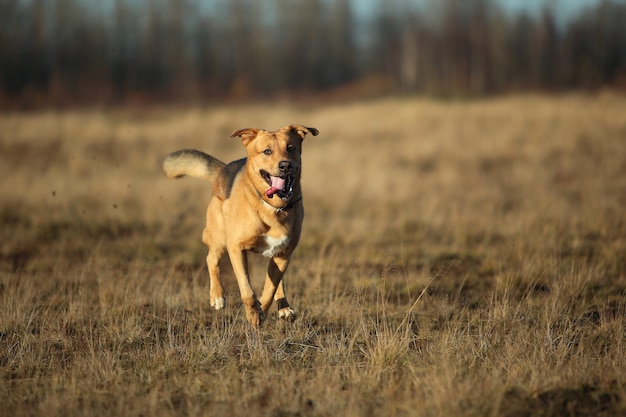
[0,0,626,107]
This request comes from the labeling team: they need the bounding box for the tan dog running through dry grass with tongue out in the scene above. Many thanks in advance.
[163,125,319,327]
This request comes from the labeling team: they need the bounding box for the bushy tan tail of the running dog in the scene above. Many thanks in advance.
[163,149,225,181]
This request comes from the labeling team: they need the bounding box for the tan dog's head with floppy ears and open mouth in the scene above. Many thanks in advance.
[231,125,319,201]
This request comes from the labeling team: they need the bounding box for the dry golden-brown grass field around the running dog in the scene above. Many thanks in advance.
[0,93,626,417]
